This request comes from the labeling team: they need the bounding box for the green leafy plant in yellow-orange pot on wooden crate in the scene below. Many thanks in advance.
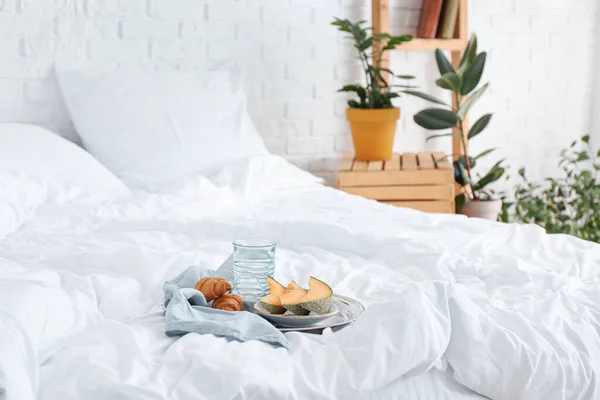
[331,18,414,161]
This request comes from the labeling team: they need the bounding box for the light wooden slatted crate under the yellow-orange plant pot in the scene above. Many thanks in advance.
[337,152,454,213]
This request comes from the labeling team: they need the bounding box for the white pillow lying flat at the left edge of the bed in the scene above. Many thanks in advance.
[0,123,129,197]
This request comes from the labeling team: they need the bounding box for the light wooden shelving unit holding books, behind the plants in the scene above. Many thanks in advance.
[371,0,469,159]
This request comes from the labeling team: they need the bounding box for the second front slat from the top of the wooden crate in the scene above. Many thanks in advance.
[342,185,454,201]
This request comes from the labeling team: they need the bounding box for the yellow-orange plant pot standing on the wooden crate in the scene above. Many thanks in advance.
[346,108,400,161]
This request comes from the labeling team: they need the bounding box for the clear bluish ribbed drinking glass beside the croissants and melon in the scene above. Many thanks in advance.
[233,240,275,301]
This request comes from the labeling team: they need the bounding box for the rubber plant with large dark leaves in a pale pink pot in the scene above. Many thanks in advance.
[410,35,504,220]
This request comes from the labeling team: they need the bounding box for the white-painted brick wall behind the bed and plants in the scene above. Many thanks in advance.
[0,0,600,188]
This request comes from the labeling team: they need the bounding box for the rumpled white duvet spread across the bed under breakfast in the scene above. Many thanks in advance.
[0,157,600,400]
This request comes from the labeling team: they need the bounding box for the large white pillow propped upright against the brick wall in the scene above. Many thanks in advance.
[56,65,267,191]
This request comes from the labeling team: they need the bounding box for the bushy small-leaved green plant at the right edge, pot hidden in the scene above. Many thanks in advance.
[501,135,600,243]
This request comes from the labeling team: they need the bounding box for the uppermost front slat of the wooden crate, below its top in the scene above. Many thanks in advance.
[338,169,454,188]
